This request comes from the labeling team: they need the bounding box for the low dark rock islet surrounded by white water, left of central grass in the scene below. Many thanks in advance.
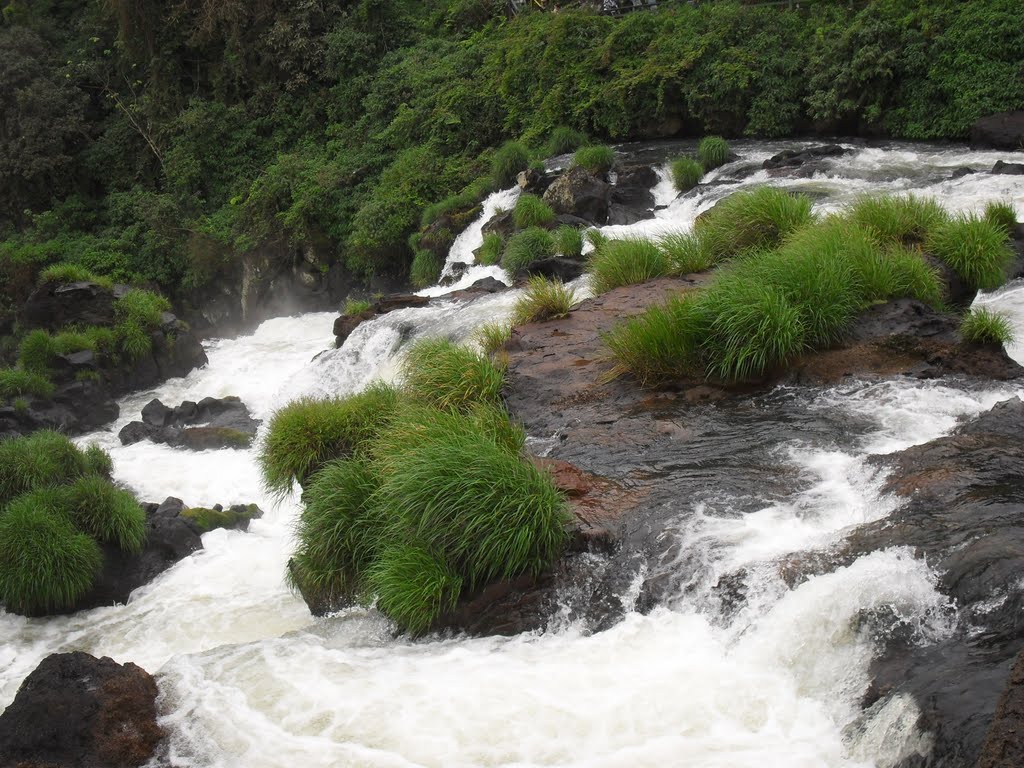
[118,395,261,451]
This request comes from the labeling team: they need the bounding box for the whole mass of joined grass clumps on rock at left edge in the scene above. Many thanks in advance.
[0,431,145,613]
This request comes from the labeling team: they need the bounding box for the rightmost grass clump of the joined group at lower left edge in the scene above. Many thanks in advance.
[58,474,145,553]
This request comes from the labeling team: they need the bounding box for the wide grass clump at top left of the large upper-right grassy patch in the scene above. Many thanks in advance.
[693,186,813,262]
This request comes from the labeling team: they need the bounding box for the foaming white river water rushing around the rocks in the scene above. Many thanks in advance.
[0,143,1024,768]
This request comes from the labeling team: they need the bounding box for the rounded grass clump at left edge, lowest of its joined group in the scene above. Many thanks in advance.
[0,488,102,614]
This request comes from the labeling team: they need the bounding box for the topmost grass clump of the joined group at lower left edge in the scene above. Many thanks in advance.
[0,429,89,507]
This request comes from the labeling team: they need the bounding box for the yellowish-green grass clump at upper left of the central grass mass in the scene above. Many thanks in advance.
[257,385,398,494]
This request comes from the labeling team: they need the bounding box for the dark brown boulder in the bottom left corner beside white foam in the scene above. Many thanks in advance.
[0,651,165,768]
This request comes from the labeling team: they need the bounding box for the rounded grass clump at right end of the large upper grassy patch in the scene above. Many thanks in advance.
[926,214,1014,291]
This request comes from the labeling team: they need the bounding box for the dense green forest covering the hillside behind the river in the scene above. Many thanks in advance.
[0,0,1024,307]
